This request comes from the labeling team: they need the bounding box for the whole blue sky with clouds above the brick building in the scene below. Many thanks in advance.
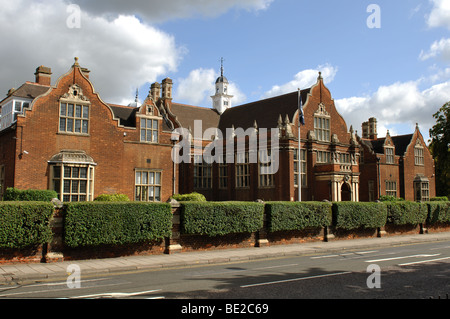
[0,0,450,139]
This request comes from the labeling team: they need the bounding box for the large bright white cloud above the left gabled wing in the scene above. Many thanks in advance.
[0,0,183,103]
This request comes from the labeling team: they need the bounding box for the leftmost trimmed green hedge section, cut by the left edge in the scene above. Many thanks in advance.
[0,202,53,249]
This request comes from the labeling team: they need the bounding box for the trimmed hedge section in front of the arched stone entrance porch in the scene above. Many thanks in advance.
[333,202,387,230]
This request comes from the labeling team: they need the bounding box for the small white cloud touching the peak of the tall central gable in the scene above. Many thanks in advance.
[263,64,338,98]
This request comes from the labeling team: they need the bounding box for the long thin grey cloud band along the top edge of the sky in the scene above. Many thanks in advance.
[73,0,273,23]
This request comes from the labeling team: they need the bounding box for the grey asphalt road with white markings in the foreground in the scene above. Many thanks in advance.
[0,241,450,302]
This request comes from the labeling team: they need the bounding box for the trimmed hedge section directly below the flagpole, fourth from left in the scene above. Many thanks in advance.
[265,202,332,232]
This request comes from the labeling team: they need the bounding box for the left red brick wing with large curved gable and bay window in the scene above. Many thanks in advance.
[0,61,178,201]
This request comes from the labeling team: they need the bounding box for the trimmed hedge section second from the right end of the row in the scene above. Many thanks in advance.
[386,201,428,225]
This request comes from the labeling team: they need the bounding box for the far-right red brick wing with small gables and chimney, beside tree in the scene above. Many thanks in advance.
[358,118,436,201]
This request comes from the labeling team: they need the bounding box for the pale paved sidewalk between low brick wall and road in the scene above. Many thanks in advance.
[0,232,450,285]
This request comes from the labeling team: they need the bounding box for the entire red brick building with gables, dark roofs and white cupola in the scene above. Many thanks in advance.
[0,60,435,201]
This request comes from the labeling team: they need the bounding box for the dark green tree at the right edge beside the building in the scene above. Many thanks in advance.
[430,102,450,196]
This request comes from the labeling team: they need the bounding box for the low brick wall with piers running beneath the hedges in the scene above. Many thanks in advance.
[0,204,450,264]
